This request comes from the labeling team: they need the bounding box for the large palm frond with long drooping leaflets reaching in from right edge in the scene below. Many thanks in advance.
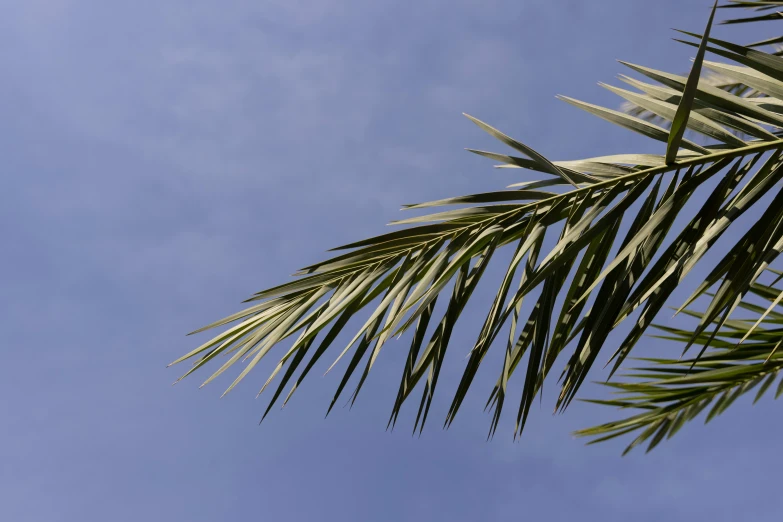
[172,2,783,446]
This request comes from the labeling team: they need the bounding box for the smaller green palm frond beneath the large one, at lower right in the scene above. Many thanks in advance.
[576,272,783,453]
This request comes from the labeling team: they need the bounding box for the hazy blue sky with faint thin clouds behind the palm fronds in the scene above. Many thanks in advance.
[0,0,783,522]
